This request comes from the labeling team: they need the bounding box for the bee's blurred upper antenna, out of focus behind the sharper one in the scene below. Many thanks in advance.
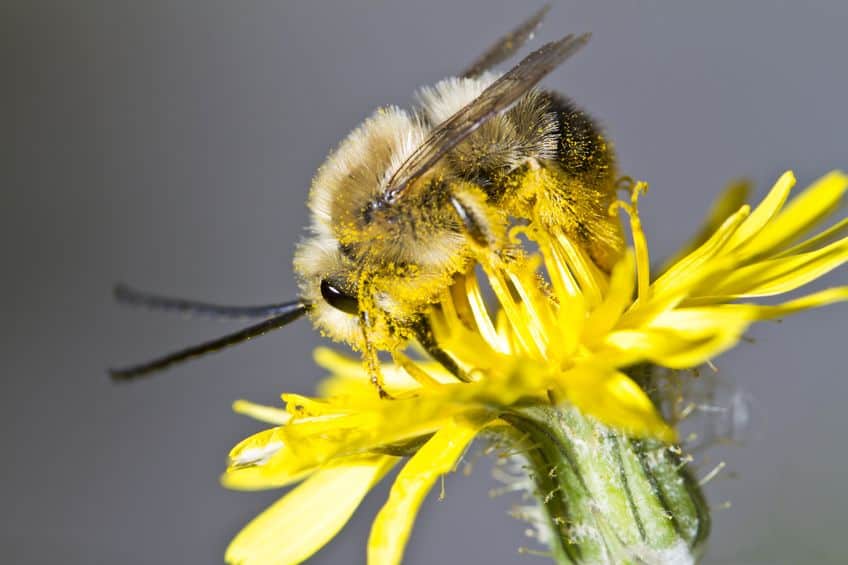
[114,283,301,318]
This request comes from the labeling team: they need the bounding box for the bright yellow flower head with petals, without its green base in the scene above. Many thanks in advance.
[223,172,848,564]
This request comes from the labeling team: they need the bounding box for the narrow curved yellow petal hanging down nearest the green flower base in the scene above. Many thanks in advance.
[368,420,480,565]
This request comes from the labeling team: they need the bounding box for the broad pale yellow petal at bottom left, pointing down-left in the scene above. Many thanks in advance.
[225,456,397,565]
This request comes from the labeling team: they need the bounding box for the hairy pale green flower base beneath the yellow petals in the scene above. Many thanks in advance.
[503,406,710,564]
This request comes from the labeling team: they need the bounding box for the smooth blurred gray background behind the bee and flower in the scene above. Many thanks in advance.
[0,0,848,564]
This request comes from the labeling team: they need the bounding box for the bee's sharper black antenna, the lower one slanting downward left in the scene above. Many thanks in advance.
[109,301,309,381]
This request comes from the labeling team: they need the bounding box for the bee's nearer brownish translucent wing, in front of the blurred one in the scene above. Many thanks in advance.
[382,33,589,200]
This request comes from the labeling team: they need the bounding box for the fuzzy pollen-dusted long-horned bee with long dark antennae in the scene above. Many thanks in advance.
[110,6,622,386]
